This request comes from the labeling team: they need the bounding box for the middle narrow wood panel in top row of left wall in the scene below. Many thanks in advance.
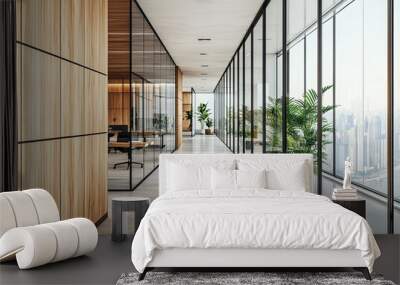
[61,0,85,64]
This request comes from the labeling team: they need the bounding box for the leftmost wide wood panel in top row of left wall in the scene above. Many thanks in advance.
[21,0,60,55]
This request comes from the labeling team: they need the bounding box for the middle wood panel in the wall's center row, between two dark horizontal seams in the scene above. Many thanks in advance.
[61,60,85,136]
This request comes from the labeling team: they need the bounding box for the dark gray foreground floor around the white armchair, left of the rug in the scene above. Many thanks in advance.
[0,235,135,285]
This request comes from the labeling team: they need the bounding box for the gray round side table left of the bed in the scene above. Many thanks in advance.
[111,197,150,241]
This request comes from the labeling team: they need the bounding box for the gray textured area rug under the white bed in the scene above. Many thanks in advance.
[117,272,395,285]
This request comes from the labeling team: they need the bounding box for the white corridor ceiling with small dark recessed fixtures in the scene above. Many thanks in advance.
[138,0,263,93]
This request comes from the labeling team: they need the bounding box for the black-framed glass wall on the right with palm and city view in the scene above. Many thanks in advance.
[214,0,400,232]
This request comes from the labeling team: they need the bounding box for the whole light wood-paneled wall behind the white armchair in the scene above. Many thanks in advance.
[16,0,108,222]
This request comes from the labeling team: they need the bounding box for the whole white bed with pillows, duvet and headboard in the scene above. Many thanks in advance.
[132,154,380,278]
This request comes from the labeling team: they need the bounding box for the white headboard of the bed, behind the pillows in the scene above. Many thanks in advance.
[159,153,314,195]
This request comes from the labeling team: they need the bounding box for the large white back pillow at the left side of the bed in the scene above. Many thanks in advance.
[168,163,212,191]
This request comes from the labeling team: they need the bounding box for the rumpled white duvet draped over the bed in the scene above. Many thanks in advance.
[132,189,380,272]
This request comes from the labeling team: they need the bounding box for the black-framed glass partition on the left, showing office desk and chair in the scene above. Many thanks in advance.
[108,1,175,190]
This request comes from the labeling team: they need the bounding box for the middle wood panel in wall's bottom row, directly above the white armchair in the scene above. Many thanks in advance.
[61,137,85,219]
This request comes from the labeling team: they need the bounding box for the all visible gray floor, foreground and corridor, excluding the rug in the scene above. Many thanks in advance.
[0,136,400,285]
